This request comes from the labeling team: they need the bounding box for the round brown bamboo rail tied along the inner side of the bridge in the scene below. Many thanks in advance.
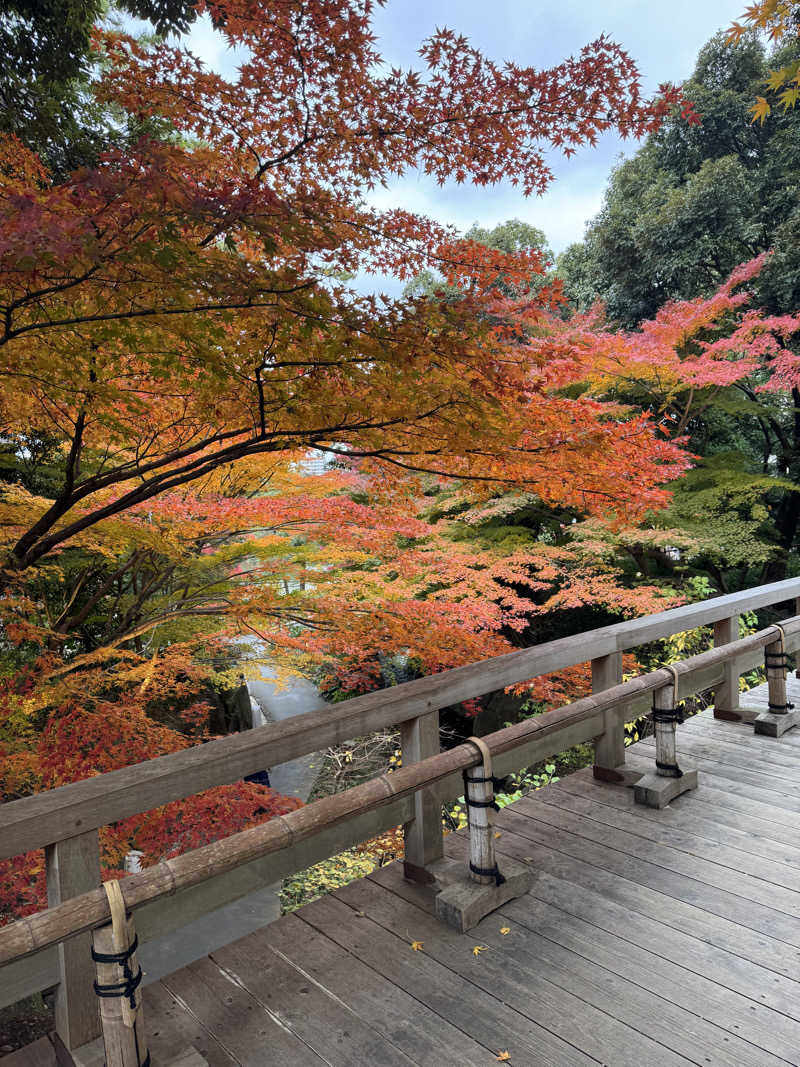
[0,617,800,966]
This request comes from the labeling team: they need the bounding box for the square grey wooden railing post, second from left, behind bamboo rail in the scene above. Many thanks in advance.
[400,711,444,883]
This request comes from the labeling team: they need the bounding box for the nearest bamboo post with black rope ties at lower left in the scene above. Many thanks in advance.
[92,881,150,1067]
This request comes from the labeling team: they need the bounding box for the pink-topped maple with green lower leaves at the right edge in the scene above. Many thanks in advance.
[556,253,800,591]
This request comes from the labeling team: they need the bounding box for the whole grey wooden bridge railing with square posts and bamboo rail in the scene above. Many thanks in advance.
[0,579,800,1048]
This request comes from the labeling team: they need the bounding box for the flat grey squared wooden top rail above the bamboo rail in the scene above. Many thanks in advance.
[0,578,800,859]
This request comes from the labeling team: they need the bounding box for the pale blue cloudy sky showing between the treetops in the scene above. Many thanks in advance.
[180,0,746,296]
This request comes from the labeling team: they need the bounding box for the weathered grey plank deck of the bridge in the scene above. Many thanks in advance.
[9,680,800,1067]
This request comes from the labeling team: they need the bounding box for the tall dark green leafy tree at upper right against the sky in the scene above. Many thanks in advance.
[559,34,800,328]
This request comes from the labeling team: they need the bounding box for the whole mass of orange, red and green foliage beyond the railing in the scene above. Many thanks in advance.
[0,0,800,934]
